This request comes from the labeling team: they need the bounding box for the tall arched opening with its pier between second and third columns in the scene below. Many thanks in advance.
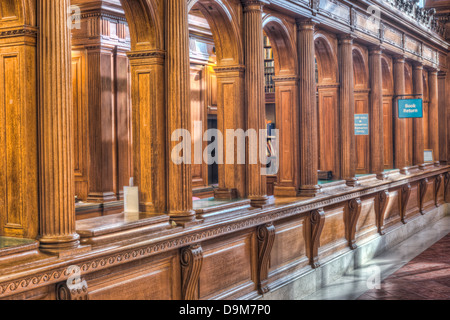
[188,0,246,200]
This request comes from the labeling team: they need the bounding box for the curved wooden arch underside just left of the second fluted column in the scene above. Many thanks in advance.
[120,0,164,51]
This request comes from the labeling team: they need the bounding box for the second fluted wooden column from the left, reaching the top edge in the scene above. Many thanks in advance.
[166,0,195,224]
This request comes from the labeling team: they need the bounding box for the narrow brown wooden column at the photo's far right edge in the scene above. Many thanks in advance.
[438,71,449,164]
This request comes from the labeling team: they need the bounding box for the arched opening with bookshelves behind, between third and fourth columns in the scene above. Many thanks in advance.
[263,14,301,196]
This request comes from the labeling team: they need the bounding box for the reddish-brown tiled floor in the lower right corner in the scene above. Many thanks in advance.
[359,234,450,300]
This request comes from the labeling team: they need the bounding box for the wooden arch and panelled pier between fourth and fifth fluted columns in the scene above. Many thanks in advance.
[314,31,340,179]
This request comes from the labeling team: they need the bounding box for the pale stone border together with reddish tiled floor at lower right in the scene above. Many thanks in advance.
[305,216,450,300]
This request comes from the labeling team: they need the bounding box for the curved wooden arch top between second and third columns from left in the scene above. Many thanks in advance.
[188,0,244,66]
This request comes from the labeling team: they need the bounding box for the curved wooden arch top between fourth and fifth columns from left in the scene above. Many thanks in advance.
[314,31,339,84]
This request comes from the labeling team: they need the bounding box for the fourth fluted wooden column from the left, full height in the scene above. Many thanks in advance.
[297,20,321,197]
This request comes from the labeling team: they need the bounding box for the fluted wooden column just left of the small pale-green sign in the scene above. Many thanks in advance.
[339,35,358,187]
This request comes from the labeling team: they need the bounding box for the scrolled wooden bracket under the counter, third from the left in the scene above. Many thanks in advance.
[257,223,275,294]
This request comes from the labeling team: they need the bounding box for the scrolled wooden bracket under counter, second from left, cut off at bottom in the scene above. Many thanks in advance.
[180,244,203,300]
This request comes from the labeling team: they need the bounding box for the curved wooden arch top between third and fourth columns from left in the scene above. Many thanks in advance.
[263,14,297,76]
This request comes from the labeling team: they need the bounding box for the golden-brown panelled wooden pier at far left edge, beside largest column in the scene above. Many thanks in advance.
[0,45,38,238]
